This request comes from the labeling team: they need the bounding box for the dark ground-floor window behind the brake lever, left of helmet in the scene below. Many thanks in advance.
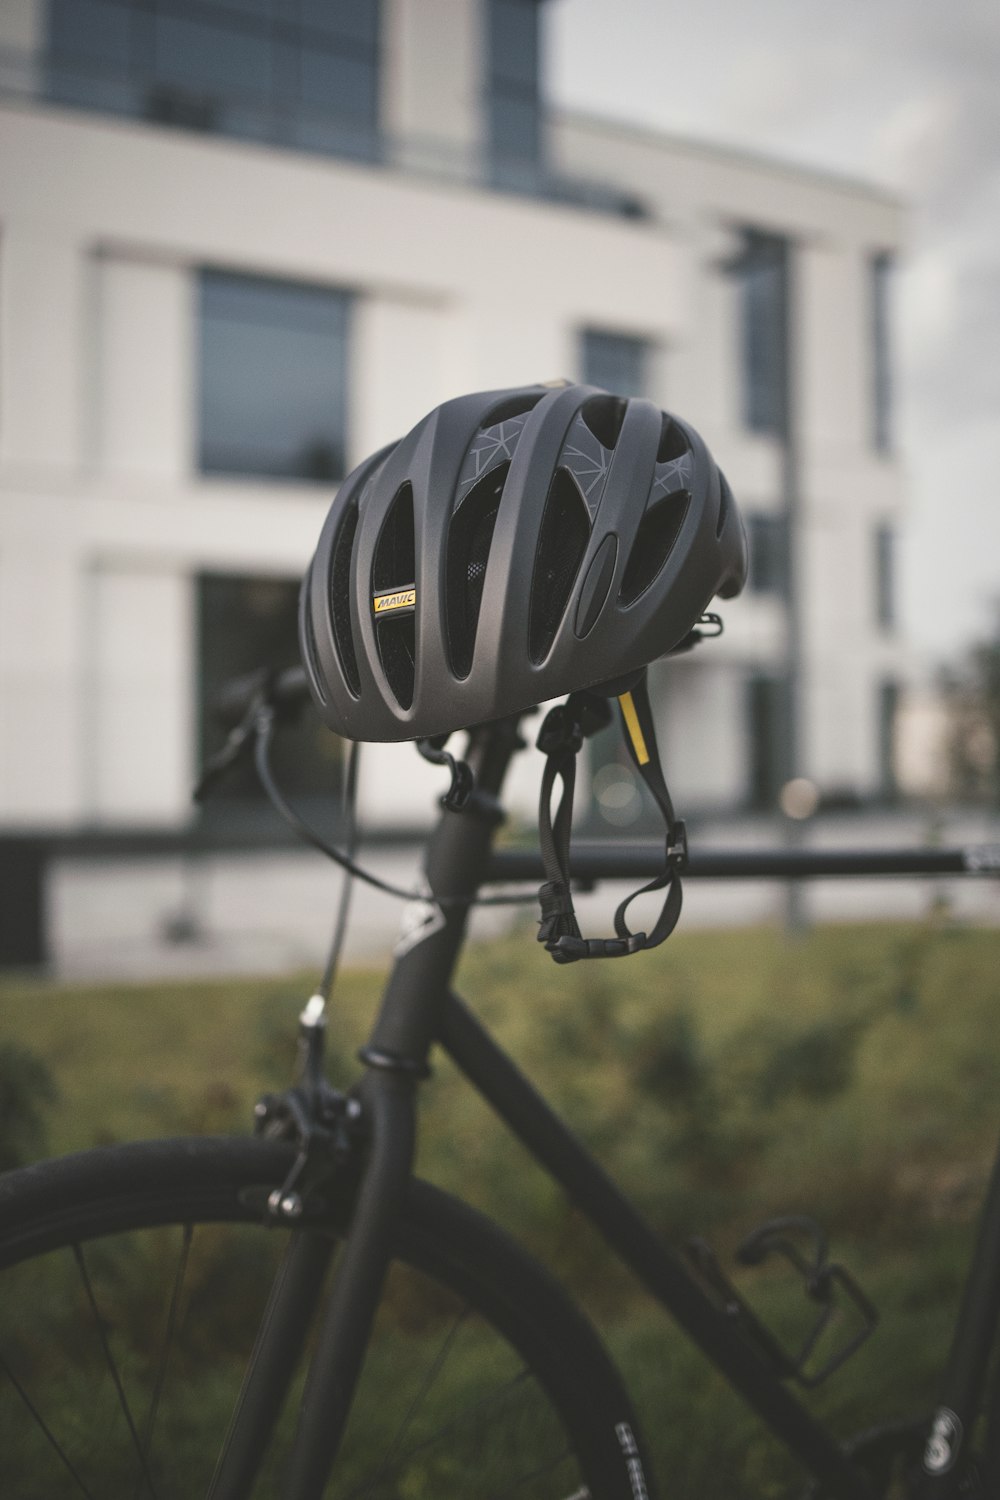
[196,573,340,827]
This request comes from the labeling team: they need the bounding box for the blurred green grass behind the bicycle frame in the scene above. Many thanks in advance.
[0,921,1000,1500]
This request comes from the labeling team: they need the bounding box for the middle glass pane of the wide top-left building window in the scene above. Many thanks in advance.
[154,15,271,99]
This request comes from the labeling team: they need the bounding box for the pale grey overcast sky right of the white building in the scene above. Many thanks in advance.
[546,0,1000,659]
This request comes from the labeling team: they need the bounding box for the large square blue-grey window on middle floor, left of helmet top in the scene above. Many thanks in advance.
[199,272,351,482]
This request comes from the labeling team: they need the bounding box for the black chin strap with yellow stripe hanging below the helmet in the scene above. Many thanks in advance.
[538,672,688,963]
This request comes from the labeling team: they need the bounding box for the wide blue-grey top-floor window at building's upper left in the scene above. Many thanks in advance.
[48,0,379,159]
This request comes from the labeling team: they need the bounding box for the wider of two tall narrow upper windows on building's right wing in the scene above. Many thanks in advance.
[730,230,789,437]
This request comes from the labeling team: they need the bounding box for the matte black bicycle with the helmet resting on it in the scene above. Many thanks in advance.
[0,672,1000,1500]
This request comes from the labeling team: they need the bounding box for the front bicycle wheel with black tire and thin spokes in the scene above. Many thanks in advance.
[0,1139,652,1500]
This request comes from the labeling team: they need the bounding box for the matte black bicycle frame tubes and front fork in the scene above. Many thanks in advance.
[211,722,1000,1500]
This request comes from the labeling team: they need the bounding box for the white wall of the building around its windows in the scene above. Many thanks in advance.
[0,83,901,824]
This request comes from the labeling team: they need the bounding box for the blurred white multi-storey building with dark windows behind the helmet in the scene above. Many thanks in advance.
[0,0,904,960]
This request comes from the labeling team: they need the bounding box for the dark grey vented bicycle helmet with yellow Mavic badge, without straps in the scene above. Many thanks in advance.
[300,383,747,740]
